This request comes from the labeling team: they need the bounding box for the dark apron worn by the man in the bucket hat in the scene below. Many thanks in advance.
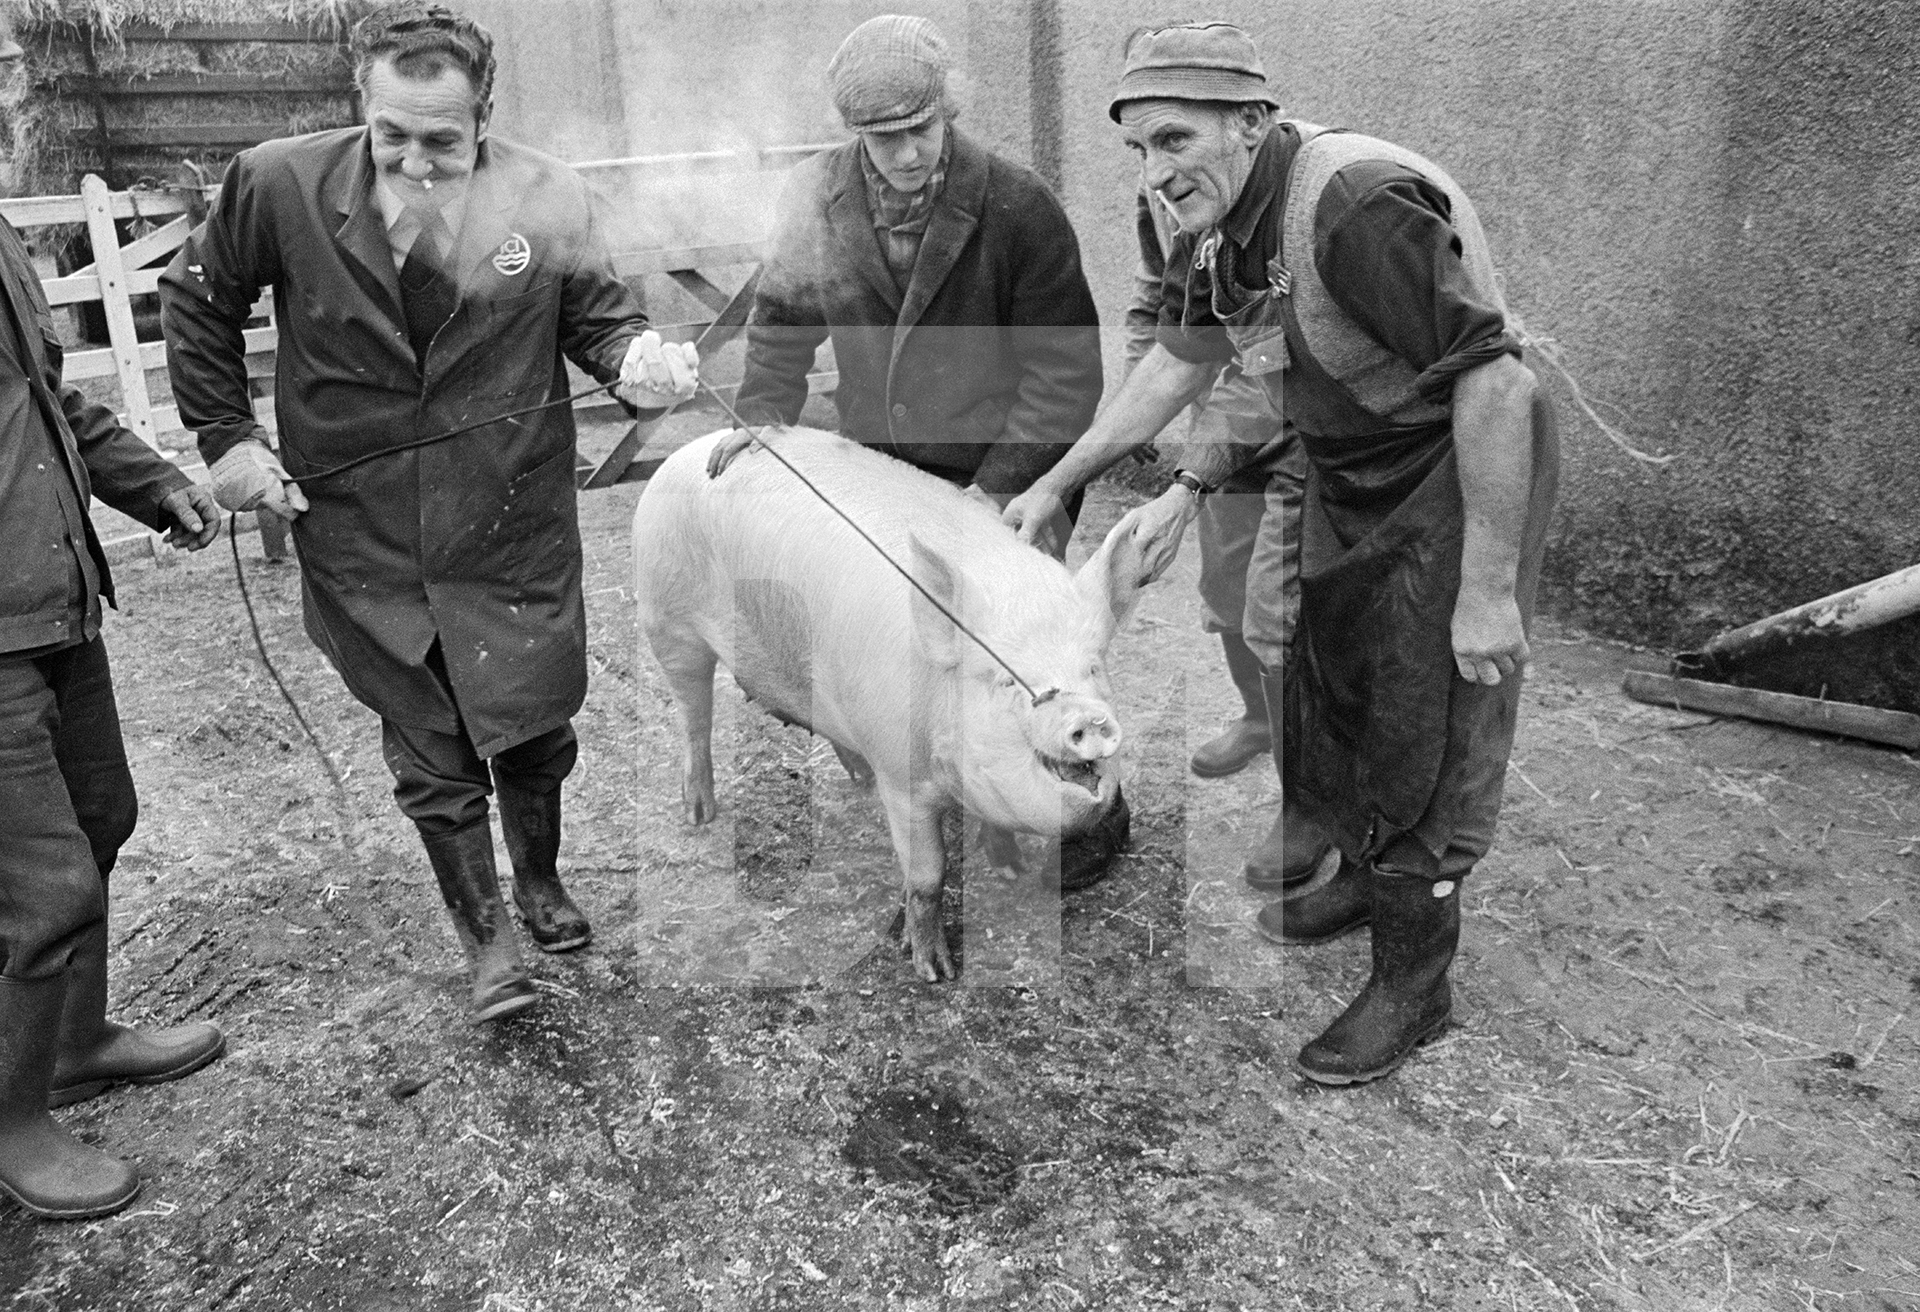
[1215,222,1559,880]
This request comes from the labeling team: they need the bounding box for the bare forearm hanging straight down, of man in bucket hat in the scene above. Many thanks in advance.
[1453,355,1536,595]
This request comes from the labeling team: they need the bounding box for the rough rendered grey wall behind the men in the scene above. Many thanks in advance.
[468,0,1920,705]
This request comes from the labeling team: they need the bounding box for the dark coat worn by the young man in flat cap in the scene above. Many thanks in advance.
[739,127,1102,494]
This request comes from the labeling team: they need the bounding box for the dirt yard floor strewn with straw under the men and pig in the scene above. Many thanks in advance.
[0,413,1920,1312]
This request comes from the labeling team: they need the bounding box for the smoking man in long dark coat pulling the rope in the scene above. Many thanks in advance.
[159,2,695,1020]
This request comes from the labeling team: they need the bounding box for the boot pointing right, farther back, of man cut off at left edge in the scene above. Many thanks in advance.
[46,920,227,1106]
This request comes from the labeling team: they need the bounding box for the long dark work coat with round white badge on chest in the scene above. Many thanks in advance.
[159,129,647,757]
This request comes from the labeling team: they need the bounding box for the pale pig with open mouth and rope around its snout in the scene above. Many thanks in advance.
[634,428,1144,984]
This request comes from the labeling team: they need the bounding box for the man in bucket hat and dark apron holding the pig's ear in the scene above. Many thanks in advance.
[1006,23,1557,1085]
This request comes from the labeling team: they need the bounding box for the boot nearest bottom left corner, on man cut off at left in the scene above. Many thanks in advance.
[0,972,140,1220]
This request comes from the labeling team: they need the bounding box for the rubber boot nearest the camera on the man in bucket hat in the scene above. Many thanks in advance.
[1298,870,1459,1083]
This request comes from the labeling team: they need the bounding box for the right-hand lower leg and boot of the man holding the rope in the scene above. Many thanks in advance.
[493,724,593,953]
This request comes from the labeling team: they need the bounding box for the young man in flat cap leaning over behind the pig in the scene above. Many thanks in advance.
[708,13,1129,889]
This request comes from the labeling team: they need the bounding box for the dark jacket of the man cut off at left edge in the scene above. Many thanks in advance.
[0,219,190,657]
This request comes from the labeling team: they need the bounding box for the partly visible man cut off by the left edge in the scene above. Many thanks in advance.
[0,10,227,1218]
